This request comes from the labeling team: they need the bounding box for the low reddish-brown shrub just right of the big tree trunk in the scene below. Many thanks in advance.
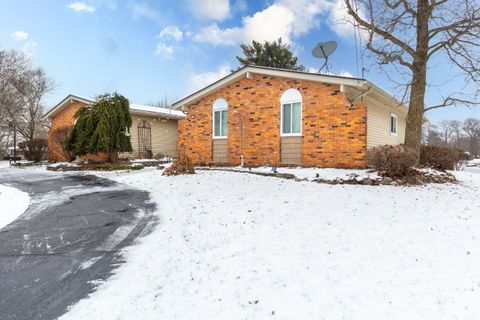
[420,145,470,171]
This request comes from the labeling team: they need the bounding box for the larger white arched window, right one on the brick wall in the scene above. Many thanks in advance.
[280,89,302,136]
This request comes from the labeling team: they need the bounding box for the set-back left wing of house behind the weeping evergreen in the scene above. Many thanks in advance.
[44,95,185,161]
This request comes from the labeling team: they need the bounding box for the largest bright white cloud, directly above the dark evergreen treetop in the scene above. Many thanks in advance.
[194,0,334,46]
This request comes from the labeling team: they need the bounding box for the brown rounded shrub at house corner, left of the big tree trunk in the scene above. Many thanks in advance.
[367,145,418,178]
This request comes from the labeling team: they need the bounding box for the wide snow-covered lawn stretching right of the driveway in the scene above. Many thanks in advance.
[61,169,480,320]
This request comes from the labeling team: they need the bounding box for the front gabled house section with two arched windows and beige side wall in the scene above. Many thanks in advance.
[173,66,407,168]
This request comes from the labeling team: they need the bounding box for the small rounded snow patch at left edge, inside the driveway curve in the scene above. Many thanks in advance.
[0,184,30,229]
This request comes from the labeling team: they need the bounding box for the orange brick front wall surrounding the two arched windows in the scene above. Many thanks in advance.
[179,75,367,168]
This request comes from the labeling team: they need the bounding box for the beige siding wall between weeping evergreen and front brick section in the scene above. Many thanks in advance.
[126,114,178,156]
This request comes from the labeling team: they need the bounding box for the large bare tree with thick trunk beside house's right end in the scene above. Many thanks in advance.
[343,0,480,152]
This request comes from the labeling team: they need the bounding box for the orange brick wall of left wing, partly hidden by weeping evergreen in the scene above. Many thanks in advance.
[48,101,110,162]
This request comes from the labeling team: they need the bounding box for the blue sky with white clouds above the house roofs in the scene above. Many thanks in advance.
[0,0,480,122]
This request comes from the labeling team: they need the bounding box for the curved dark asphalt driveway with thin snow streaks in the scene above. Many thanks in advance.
[0,169,156,320]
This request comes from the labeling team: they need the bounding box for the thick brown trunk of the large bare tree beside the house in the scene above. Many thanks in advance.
[405,0,430,154]
